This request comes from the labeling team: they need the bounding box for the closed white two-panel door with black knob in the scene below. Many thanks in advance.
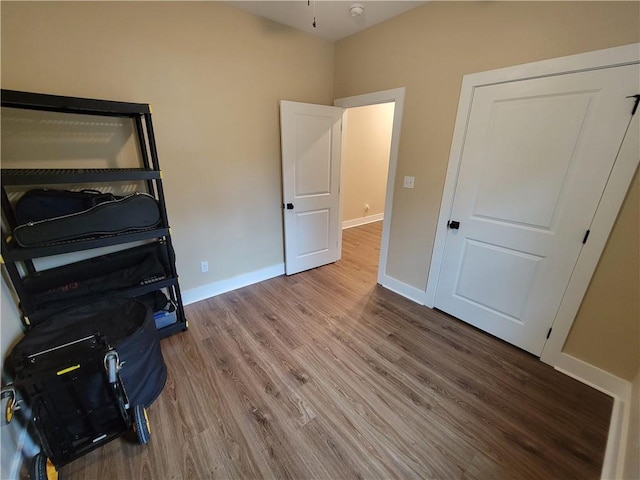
[435,65,640,355]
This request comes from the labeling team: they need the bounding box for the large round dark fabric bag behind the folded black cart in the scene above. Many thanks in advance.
[7,298,167,407]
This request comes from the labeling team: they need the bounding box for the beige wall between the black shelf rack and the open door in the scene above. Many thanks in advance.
[1,1,334,290]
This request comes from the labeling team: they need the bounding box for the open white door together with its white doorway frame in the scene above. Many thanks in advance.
[280,87,405,280]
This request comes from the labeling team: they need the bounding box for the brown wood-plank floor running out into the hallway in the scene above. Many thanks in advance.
[61,224,612,480]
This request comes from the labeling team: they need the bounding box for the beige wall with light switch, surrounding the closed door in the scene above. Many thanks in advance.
[334,2,640,380]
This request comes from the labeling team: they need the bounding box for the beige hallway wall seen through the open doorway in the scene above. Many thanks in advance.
[340,103,395,222]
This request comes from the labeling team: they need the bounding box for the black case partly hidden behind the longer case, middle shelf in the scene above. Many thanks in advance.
[15,188,122,225]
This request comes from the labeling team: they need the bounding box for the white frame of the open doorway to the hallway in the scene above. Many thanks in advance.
[333,87,406,285]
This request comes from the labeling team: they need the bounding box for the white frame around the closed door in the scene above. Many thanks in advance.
[424,43,640,368]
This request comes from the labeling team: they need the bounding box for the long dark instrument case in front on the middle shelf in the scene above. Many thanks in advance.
[13,193,161,247]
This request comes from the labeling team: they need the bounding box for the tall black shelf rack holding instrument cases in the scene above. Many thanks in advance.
[0,89,188,337]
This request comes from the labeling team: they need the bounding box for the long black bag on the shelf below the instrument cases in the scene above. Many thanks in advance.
[22,242,171,318]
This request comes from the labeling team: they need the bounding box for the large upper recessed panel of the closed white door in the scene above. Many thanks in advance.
[473,94,593,229]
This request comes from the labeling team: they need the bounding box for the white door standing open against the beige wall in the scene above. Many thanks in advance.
[280,100,342,275]
